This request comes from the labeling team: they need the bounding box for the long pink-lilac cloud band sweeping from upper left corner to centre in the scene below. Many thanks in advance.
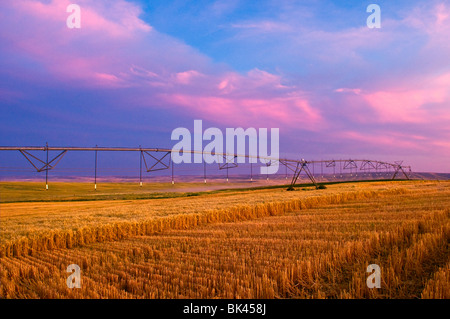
[0,0,323,130]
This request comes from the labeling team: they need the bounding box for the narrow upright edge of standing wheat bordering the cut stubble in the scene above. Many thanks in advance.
[0,188,407,258]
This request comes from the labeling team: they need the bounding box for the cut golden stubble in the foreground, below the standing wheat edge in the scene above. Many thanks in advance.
[0,186,450,298]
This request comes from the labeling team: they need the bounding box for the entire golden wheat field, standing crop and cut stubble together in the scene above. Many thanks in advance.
[0,181,450,299]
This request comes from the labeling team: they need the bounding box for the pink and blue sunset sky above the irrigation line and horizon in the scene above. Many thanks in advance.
[0,0,450,173]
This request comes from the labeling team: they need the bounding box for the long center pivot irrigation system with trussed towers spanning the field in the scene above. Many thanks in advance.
[0,144,411,190]
